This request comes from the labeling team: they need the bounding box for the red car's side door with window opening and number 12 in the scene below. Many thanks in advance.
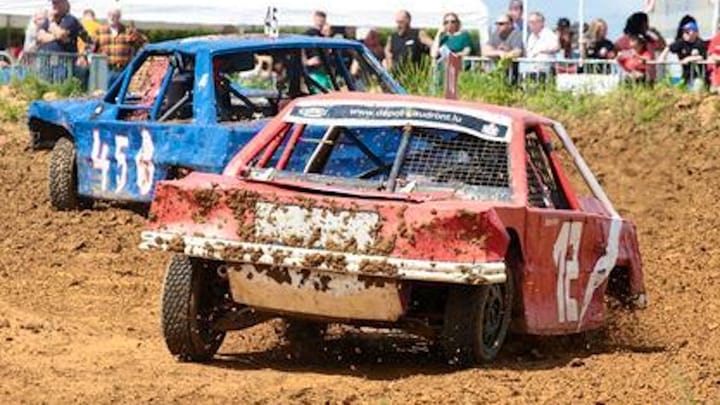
[522,126,610,334]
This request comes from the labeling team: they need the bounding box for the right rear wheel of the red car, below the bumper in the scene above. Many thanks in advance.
[442,275,513,366]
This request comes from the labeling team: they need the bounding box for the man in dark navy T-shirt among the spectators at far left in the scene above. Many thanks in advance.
[37,0,92,54]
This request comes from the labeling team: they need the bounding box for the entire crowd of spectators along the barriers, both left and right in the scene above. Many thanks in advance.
[9,0,720,88]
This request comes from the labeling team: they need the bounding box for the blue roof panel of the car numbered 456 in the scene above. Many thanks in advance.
[145,34,362,54]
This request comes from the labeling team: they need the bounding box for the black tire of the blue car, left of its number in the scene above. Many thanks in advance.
[48,138,81,211]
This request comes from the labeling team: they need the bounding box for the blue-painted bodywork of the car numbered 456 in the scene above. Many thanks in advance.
[28,35,405,202]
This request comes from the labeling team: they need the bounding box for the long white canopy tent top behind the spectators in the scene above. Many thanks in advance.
[0,0,488,37]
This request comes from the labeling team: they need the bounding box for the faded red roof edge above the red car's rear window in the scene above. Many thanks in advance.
[284,92,555,125]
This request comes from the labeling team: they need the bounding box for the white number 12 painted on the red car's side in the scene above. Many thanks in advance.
[553,222,583,322]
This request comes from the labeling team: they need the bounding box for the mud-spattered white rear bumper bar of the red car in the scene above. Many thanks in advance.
[140,232,506,284]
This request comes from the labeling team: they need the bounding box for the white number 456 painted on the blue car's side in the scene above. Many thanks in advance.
[90,129,155,195]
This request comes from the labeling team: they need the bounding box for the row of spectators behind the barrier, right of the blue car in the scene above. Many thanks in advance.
[323,0,720,88]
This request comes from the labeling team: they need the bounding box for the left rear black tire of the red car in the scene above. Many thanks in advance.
[162,255,225,362]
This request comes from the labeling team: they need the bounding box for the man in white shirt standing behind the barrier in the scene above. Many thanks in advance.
[525,12,560,81]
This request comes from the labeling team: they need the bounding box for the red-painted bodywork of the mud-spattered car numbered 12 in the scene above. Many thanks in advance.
[149,93,645,334]
